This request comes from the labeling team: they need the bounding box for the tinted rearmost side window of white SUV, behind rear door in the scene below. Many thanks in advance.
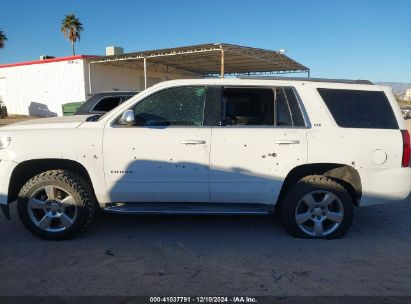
[318,89,398,129]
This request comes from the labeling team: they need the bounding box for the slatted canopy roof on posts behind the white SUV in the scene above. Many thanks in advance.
[90,43,309,76]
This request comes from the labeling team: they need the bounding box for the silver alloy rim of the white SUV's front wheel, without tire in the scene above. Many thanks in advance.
[27,185,77,232]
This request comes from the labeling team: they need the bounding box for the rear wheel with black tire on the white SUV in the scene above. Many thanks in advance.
[279,175,354,239]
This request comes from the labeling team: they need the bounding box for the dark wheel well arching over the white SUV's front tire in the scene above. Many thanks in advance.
[8,159,93,203]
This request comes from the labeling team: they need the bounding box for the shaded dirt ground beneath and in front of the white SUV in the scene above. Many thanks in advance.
[0,116,411,296]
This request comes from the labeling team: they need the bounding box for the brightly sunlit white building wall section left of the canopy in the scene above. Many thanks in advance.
[0,59,86,116]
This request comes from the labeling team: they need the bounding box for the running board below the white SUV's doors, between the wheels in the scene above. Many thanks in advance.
[103,203,274,215]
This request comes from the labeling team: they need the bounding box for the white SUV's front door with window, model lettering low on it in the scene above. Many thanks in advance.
[103,86,211,202]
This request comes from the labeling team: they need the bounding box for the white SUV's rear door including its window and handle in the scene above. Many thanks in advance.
[210,86,307,204]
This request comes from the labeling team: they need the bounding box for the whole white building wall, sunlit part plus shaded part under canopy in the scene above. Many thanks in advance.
[0,59,200,116]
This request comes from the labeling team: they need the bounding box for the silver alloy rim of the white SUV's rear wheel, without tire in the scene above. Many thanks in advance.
[295,190,344,237]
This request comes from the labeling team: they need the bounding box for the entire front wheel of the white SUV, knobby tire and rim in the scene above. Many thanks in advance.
[17,170,97,240]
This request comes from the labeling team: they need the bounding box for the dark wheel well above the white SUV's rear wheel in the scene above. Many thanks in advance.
[277,163,362,205]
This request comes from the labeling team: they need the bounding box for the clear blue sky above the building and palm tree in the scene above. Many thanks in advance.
[0,0,411,82]
